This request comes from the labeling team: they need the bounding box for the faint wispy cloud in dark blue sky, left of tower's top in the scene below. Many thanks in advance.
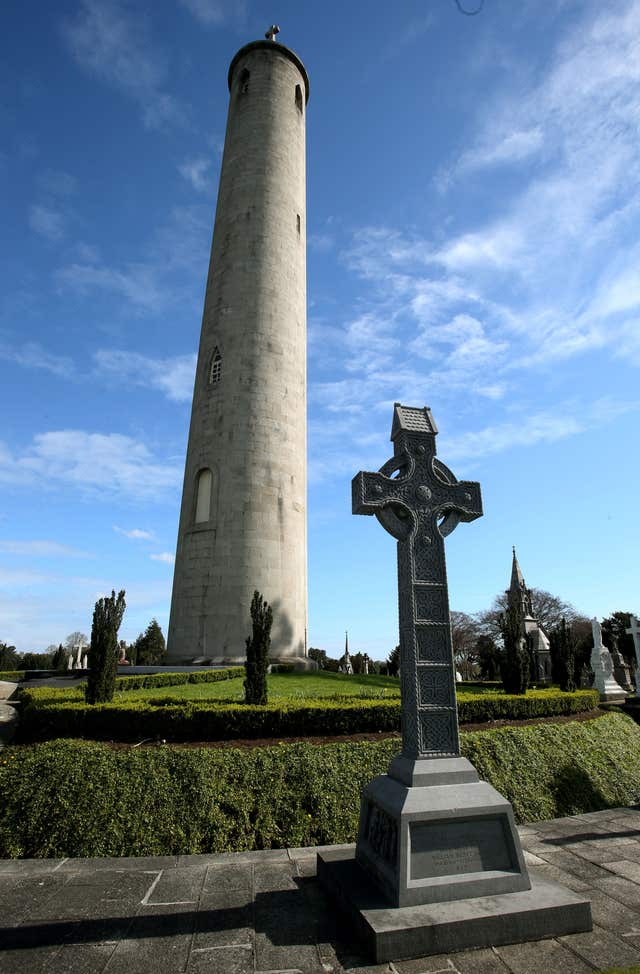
[63,0,185,128]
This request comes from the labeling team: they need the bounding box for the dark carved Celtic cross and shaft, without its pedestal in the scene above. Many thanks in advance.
[352,403,482,760]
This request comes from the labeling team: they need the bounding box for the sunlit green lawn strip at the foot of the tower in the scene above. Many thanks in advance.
[118,672,400,702]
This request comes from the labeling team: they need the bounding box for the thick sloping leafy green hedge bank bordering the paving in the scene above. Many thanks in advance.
[0,714,640,857]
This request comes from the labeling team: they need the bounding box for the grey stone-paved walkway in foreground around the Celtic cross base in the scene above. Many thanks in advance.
[0,806,640,974]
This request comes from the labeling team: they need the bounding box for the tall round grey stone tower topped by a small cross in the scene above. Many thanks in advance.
[168,27,309,663]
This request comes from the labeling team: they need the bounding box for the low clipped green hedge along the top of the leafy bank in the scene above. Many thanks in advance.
[17,687,598,743]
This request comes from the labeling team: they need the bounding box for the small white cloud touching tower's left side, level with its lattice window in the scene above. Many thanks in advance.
[94,349,196,402]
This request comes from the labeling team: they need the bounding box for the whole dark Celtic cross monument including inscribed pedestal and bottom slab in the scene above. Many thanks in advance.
[318,403,591,963]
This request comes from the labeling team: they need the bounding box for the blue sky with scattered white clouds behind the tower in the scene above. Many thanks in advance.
[0,0,640,658]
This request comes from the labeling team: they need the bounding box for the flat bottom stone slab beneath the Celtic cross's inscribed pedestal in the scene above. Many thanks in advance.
[317,846,592,964]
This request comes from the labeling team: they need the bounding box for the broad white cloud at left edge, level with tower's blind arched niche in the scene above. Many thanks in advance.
[0,430,182,500]
